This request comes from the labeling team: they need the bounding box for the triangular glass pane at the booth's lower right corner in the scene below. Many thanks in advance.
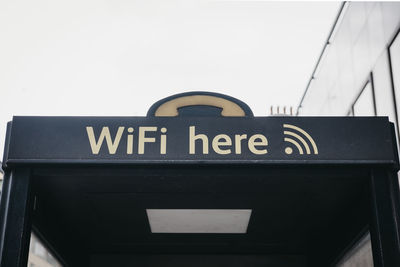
[336,234,374,267]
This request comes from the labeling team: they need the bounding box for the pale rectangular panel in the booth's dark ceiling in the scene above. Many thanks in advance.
[146,209,251,234]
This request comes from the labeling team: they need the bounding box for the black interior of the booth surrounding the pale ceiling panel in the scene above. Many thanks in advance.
[32,165,370,267]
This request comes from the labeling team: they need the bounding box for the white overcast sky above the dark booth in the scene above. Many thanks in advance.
[0,0,341,160]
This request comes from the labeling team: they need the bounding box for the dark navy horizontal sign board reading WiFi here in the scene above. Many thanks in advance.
[4,117,397,166]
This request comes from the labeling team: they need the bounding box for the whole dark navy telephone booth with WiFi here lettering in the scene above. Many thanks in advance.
[0,92,400,267]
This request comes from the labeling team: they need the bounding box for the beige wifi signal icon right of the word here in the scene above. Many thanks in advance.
[283,124,318,155]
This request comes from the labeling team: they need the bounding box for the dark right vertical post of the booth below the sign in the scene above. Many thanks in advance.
[370,169,400,267]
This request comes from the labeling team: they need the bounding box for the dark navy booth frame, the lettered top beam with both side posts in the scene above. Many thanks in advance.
[0,112,400,267]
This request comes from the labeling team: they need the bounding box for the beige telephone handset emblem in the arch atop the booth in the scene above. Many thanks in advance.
[154,95,246,117]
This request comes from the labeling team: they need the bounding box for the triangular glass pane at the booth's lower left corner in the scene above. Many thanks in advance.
[28,233,62,267]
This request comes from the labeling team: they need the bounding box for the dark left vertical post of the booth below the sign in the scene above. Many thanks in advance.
[0,168,32,267]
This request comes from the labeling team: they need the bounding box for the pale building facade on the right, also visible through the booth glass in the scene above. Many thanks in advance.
[297,2,400,267]
